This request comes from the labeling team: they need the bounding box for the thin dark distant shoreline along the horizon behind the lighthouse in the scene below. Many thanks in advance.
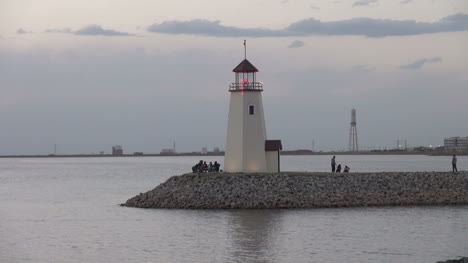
[0,150,468,158]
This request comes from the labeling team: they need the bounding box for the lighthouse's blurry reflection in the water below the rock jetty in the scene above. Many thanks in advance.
[228,210,284,262]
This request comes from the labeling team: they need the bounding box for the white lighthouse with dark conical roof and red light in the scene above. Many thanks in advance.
[224,41,282,173]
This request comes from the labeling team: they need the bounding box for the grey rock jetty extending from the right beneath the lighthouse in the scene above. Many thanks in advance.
[122,171,468,209]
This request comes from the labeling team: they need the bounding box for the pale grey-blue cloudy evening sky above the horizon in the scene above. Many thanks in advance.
[0,0,468,155]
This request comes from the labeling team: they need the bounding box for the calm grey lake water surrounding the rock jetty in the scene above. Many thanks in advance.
[0,155,468,263]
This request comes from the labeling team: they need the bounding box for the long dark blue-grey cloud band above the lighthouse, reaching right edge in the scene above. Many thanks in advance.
[147,13,468,37]
